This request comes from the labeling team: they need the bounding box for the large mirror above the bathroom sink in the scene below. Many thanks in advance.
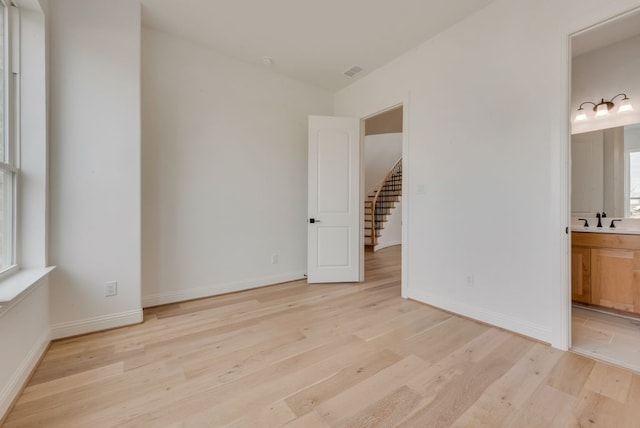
[571,124,640,218]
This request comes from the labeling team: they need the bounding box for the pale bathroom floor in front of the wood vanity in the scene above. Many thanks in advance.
[571,306,640,374]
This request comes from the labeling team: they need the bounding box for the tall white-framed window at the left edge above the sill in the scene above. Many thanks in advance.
[0,0,20,275]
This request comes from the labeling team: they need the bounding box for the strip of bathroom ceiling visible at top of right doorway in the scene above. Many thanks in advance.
[571,9,640,57]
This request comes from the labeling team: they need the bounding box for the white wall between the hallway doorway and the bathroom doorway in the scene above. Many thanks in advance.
[335,0,640,348]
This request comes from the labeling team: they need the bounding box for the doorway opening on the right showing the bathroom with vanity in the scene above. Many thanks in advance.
[570,9,640,371]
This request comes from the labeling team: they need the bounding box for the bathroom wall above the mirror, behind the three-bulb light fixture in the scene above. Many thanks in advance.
[571,36,640,134]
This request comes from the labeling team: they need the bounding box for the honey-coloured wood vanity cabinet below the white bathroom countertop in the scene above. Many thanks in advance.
[571,232,640,313]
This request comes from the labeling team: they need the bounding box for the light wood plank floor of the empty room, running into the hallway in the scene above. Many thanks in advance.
[6,247,640,428]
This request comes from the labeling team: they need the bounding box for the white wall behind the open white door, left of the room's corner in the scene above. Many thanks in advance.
[142,28,333,306]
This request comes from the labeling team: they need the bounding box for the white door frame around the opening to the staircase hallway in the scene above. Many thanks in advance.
[359,95,410,299]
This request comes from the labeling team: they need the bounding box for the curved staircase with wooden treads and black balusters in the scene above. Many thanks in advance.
[364,158,402,247]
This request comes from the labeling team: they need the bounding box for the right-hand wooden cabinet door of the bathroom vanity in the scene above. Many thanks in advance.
[591,249,640,313]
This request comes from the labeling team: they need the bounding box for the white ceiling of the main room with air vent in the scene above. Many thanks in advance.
[141,0,493,91]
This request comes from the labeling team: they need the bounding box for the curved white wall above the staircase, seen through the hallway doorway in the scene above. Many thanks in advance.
[364,132,402,194]
